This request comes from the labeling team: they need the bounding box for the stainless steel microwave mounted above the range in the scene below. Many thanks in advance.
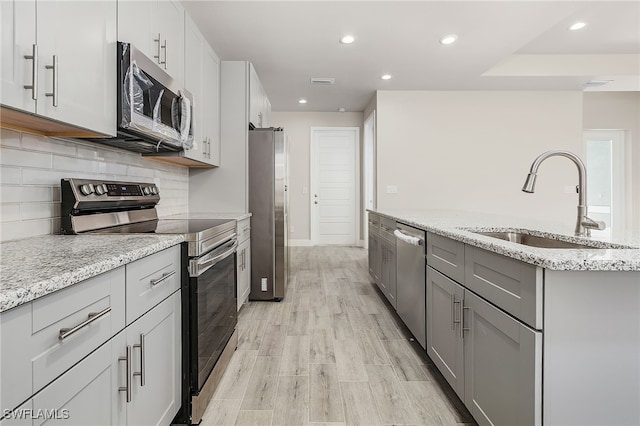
[89,42,193,154]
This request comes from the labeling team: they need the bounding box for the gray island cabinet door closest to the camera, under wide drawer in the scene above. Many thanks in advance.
[464,291,542,426]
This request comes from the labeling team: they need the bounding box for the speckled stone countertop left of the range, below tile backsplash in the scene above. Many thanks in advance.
[0,234,184,312]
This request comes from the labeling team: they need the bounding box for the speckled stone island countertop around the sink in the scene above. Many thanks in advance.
[369,209,640,272]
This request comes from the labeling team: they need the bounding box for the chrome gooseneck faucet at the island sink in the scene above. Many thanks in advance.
[522,150,606,237]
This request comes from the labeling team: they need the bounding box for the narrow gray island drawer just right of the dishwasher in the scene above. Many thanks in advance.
[427,233,464,283]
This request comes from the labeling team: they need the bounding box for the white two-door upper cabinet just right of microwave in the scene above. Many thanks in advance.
[184,14,220,166]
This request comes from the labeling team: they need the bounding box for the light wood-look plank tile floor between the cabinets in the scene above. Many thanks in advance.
[201,247,475,426]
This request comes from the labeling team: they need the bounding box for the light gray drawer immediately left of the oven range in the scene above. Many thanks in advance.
[126,246,181,325]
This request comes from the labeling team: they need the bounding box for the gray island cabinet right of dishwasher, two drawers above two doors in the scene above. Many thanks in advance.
[427,234,543,425]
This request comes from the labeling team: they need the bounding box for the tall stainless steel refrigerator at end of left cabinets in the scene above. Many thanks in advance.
[249,128,289,301]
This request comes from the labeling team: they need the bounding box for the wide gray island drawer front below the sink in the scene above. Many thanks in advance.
[464,245,543,330]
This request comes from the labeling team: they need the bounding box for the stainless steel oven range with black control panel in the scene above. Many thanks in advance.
[61,179,238,424]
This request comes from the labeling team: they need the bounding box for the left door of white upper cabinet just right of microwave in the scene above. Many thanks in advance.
[184,14,207,165]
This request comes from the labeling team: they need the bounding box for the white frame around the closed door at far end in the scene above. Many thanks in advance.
[309,126,361,246]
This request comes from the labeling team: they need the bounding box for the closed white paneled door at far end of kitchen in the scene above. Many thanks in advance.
[310,127,360,245]
